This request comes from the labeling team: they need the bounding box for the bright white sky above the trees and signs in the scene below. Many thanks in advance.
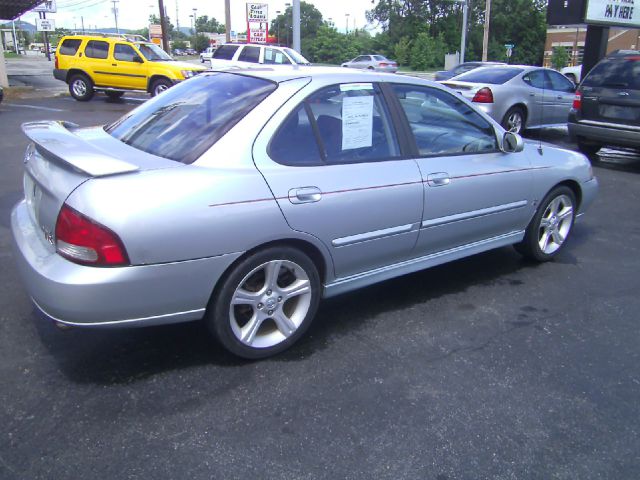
[15,0,377,32]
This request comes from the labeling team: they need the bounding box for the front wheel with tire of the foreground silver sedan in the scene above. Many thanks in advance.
[514,185,576,262]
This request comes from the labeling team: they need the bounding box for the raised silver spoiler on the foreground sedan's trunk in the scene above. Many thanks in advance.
[22,121,139,177]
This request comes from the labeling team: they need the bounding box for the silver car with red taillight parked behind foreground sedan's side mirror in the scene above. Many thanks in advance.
[442,65,576,133]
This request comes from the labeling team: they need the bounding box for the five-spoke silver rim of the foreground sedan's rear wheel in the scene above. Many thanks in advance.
[229,260,313,348]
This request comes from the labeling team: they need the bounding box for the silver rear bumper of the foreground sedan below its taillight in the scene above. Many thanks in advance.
[11,201,240,327]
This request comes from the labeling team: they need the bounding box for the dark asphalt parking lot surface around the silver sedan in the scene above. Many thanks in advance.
[0,91,640,480]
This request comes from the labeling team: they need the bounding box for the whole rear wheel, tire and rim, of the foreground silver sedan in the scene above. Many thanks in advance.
[205,247,320,359]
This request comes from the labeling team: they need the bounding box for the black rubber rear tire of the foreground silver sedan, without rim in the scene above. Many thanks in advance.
[205,246,321,360]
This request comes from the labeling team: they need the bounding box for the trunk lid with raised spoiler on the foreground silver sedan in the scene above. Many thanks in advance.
[22,121,182,245]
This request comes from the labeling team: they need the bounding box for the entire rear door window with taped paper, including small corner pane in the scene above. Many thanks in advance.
[269,83,400,165]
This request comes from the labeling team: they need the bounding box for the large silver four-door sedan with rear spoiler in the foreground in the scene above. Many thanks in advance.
[11,67,597,358]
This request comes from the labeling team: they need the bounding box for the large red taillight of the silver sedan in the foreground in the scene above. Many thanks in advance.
[56,204,129,267]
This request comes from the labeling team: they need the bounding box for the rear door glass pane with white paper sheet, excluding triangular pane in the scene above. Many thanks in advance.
[306,83,400,164]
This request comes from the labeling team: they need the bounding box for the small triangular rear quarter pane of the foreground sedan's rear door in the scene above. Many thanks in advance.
[269,103,323,166]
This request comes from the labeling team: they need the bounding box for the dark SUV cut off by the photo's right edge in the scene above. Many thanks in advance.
[568,50,640,155]
